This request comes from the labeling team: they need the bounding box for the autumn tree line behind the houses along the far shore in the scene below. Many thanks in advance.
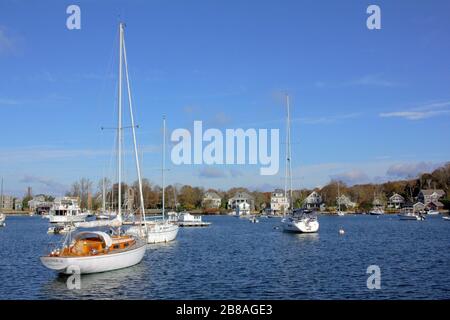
[66,162,450,211]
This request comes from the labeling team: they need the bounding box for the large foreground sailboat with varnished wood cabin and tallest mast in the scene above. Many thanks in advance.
[40,23,146,274]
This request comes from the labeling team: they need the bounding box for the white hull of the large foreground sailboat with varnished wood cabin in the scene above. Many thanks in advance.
[41,243,146,274]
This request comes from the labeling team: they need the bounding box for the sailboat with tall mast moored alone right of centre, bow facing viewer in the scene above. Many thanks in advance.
[281,95,319,233]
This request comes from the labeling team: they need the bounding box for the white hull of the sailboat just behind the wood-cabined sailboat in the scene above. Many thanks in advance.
[127,222,179,244]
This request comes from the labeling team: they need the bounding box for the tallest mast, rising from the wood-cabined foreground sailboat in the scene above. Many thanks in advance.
[117,22,123,218]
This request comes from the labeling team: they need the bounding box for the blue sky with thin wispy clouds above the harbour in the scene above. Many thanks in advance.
[0,0,450,195]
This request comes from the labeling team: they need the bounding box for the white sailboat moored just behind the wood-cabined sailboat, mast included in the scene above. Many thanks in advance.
[127,117,179,244]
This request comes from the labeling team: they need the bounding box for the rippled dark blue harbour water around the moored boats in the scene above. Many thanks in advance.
[0,216,450,299]
